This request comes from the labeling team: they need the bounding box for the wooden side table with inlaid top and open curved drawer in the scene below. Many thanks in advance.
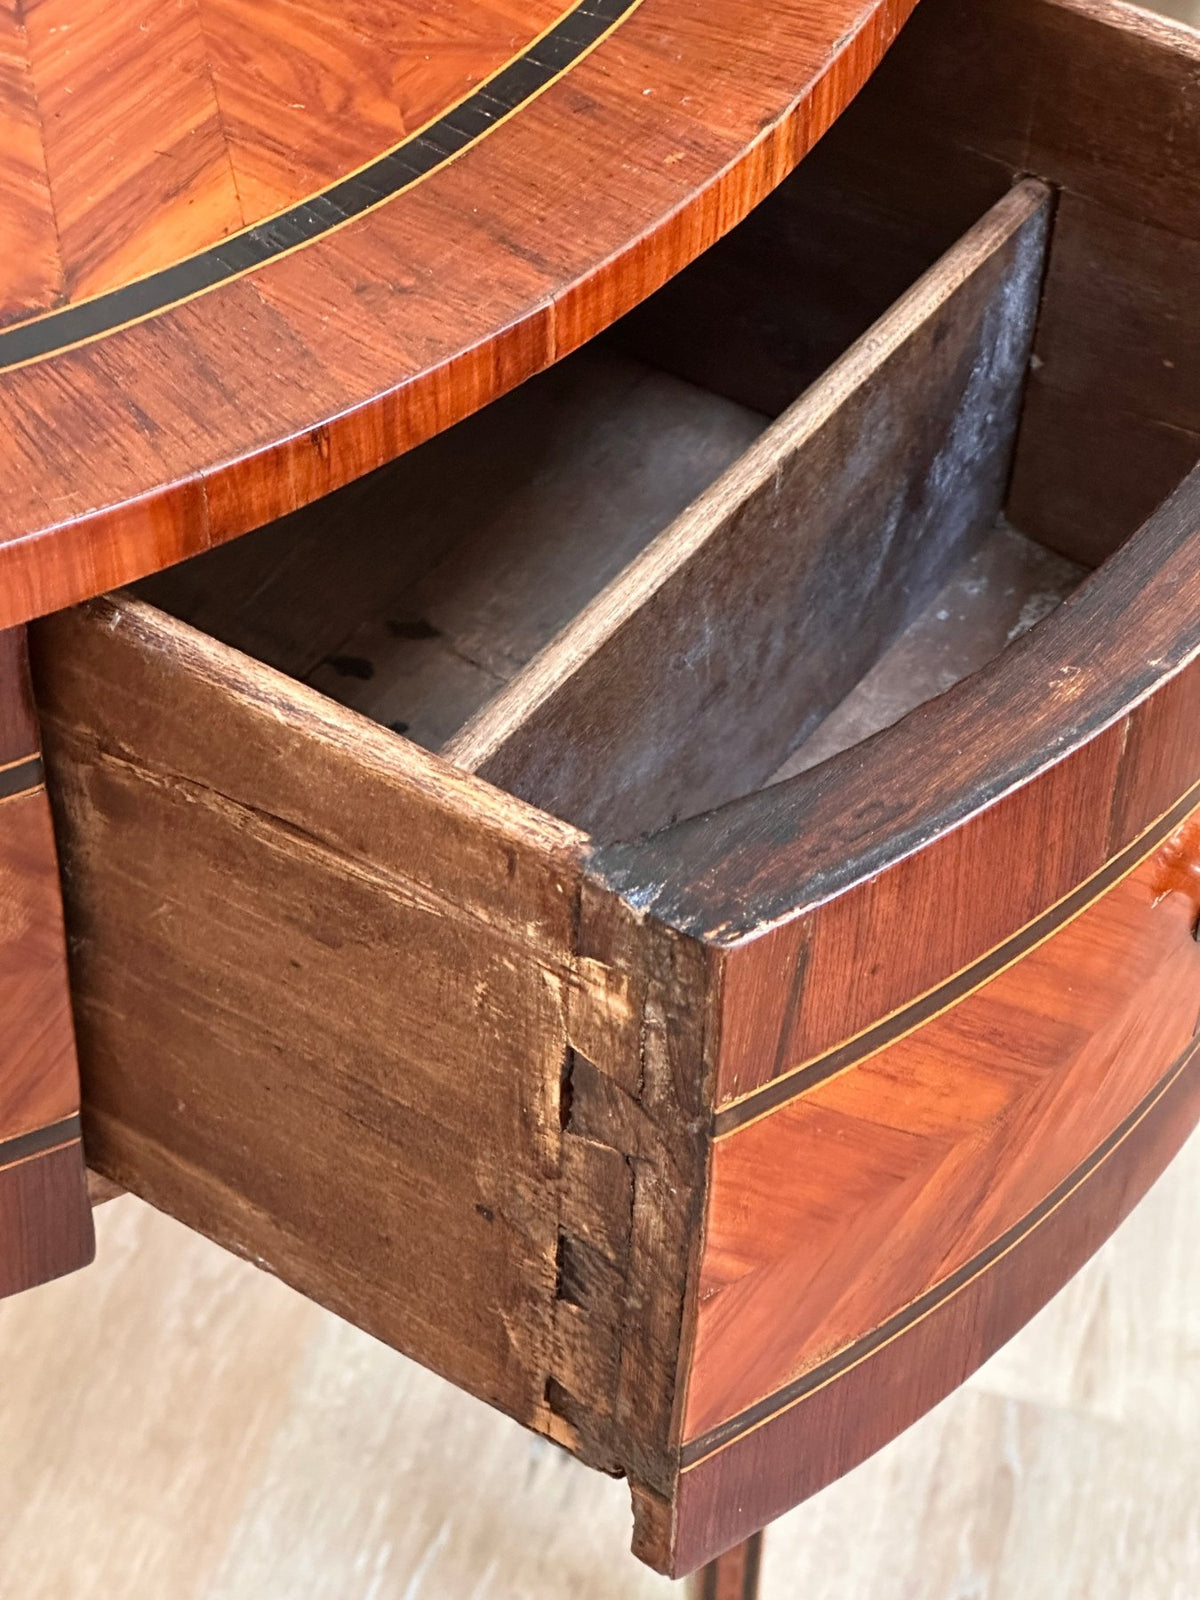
[0,0,1200,1600]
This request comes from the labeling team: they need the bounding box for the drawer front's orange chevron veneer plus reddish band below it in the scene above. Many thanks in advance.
[682,789,1200,1561]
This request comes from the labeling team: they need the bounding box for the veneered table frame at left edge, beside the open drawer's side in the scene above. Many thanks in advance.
[0,629,94,1296]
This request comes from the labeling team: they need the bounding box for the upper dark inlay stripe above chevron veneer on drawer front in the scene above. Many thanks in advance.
[712,784,1200,1139]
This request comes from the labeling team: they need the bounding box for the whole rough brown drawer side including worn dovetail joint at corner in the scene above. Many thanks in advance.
[37,588,720,1523]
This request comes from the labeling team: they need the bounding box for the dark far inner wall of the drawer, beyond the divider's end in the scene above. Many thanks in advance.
[732,0,1200,565]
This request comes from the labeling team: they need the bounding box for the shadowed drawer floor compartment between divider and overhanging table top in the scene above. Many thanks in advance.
[138,349,766,749]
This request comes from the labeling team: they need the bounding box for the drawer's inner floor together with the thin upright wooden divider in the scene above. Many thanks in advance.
[138,175,1107,840]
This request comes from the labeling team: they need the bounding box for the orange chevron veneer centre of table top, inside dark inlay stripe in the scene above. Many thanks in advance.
[0,0,565,320]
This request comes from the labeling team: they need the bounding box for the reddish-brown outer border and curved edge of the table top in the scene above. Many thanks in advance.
[0,0,915,627]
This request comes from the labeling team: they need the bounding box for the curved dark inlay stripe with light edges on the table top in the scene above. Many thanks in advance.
[0,0,642,371]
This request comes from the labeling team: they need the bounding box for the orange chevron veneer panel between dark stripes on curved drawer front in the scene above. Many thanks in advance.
[683,811,1200,1448]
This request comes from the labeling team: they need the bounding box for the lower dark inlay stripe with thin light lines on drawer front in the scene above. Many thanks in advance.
[680,1038,1200,1470]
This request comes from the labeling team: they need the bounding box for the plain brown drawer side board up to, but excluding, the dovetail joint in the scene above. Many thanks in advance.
[38,603,578,1426]
